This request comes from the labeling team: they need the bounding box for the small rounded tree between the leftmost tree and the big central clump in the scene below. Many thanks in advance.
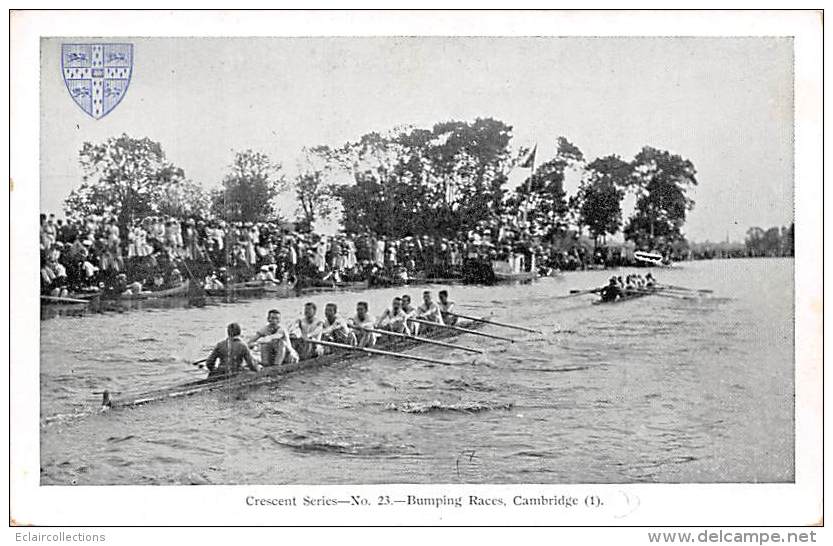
[211,150,286,222]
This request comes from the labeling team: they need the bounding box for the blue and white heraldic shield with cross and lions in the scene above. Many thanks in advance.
[61,44,133,119]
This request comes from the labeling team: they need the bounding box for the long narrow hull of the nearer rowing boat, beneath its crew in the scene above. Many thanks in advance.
[102,321,484,409]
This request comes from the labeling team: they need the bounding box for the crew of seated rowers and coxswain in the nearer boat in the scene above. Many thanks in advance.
[205,290,457,373]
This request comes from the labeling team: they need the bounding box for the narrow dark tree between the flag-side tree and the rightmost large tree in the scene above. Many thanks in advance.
[574,155,633,244]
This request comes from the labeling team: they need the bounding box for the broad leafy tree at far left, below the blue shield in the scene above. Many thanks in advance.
[64,134,195,238]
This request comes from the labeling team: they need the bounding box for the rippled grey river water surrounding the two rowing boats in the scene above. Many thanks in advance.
[40,259,794,485]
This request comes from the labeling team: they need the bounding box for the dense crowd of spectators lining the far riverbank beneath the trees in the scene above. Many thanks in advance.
[40,210,608,296]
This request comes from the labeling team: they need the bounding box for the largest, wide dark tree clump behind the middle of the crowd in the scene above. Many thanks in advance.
[335,119,511,237]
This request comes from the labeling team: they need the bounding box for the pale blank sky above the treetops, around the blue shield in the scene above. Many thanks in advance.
[40,37,794,241]
